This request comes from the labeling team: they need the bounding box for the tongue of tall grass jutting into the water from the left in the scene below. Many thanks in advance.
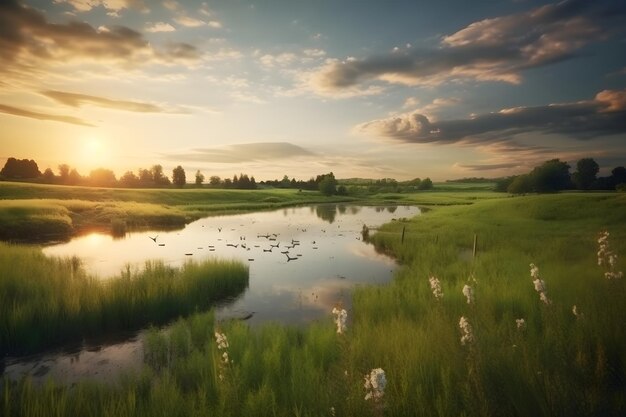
[0,243,248,354]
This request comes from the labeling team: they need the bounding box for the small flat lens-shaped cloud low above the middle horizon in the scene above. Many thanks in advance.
[166,142,315,164]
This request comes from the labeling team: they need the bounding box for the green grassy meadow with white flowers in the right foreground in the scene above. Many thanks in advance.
[2,193,626,416]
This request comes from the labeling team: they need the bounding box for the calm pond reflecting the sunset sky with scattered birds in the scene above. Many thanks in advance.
[2,204,419,383]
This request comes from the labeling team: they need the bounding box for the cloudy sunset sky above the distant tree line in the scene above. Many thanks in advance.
[0,0,626,181]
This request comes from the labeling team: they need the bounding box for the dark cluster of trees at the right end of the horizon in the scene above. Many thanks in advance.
[495,158,626,194]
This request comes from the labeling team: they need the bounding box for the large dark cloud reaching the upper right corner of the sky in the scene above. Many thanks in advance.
[311,0,626,95]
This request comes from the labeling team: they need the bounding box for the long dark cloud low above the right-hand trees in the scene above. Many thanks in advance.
[356,89,626,144]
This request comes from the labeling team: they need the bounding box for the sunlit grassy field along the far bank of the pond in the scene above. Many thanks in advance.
[0,182,503,241]
